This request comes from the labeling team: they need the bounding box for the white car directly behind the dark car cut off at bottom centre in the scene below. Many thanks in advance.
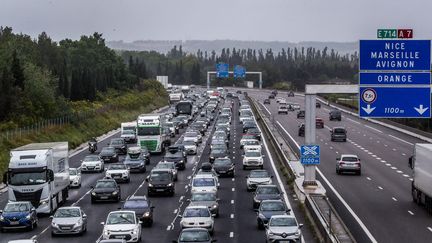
[180,206,215,234]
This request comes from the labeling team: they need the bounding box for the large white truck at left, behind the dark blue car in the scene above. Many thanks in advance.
[3,142,70,214]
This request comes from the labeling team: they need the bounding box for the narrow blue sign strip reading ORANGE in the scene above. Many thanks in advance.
[360,72,431,86]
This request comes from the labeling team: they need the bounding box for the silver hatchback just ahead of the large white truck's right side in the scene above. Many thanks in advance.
[50,207,87,236]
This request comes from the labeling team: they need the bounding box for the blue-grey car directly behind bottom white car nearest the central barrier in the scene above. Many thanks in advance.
[256,200,291,229]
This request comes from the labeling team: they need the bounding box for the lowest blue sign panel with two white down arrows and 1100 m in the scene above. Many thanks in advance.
[359,86,431,118]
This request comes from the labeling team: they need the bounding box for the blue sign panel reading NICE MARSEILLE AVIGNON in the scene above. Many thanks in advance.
[360,40,431,71]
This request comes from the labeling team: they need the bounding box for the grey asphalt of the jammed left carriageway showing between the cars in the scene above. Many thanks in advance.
[0,95,313,243]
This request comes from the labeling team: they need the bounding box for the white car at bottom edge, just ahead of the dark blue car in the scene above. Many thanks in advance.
[101,211,141,242]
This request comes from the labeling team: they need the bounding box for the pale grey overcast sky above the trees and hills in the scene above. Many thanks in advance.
[0,0,432,42]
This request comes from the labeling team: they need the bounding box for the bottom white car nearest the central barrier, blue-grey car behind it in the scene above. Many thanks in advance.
[266,215,303,242]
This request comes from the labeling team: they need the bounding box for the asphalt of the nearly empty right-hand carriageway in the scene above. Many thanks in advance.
[248,90,432,242]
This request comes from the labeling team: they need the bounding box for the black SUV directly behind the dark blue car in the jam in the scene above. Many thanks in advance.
[146,169,175,197]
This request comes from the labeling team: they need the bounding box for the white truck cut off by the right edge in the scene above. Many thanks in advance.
[409,143,432,213]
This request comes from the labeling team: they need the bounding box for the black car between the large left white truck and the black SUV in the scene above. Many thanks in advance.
[90,179,121,203]
